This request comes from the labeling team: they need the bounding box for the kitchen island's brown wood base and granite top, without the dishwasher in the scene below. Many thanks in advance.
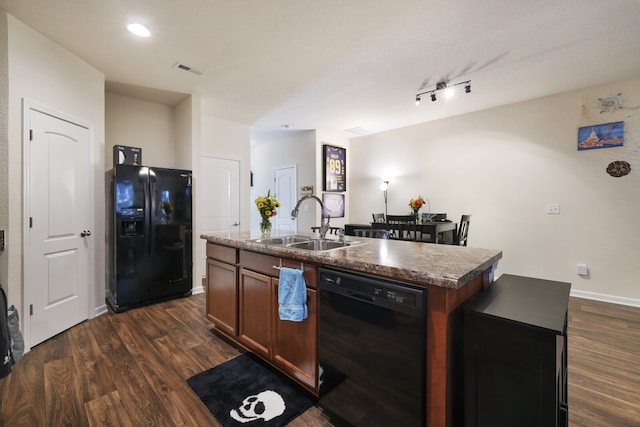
[201,232,502,426]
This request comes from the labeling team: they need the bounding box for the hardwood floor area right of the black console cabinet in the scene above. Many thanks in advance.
[567,298,640,427]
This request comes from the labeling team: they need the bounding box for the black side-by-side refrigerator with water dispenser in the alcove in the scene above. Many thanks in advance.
[106,165,193,313]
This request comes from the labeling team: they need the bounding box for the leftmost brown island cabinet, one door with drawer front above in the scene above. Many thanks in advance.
[206,243,238,337]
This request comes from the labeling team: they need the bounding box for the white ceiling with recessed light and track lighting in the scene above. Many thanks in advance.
[0,0,640,144]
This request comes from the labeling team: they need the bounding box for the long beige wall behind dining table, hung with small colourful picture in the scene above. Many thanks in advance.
[349,77,640,305]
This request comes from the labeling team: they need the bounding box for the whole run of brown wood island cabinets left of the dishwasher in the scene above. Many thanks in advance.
[206,243,318,393]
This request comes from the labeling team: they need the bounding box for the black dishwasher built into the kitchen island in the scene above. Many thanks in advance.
[318,268,427,427]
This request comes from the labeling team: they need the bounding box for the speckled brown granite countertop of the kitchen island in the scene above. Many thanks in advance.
[200,231,502,289]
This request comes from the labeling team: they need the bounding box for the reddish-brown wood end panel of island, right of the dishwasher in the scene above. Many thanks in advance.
[427,272,492,427]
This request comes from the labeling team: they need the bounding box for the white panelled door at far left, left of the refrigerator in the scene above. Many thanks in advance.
[25,109,94,346]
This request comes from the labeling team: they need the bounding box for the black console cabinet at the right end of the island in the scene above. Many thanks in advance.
[464,274,571,427]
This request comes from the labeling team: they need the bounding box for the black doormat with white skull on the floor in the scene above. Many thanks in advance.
[187,353,315,427]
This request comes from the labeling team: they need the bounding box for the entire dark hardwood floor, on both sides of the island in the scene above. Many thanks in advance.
[0,294,640,427]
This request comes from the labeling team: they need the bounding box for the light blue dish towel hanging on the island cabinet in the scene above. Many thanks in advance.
[278,267,307,322]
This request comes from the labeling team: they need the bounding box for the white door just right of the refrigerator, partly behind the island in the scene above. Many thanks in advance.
[196,156,240,277]
